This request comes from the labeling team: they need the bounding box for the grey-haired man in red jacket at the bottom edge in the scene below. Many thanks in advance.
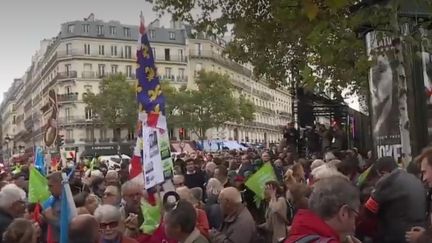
[285,176,360,243]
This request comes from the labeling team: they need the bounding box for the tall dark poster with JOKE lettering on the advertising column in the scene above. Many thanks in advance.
[366,32,402,160]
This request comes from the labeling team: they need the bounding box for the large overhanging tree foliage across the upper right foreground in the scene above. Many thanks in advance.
[147,0,432,96]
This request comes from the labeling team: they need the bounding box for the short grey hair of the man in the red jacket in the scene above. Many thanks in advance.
[309,176,360,220]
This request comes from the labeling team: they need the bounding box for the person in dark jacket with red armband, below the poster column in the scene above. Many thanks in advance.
[360,157,426,243]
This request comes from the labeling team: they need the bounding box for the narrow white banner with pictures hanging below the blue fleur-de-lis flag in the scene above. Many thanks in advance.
[143,126,165,189]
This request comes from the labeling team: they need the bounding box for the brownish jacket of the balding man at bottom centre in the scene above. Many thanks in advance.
[210,205,257,243]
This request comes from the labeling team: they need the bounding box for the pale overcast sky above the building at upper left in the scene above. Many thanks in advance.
[0,0,168,102]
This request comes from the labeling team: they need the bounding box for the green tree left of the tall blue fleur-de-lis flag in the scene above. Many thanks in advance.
[84,74,138,129]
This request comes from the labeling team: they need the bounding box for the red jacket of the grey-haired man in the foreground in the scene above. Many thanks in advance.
[285,209,341,243]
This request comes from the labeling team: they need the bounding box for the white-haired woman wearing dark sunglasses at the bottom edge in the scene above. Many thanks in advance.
[94,205,137,243]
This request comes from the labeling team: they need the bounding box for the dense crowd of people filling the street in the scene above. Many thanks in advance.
[0,139,432,243]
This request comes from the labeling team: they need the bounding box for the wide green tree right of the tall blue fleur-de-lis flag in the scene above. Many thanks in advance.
[162,71,255,138]
